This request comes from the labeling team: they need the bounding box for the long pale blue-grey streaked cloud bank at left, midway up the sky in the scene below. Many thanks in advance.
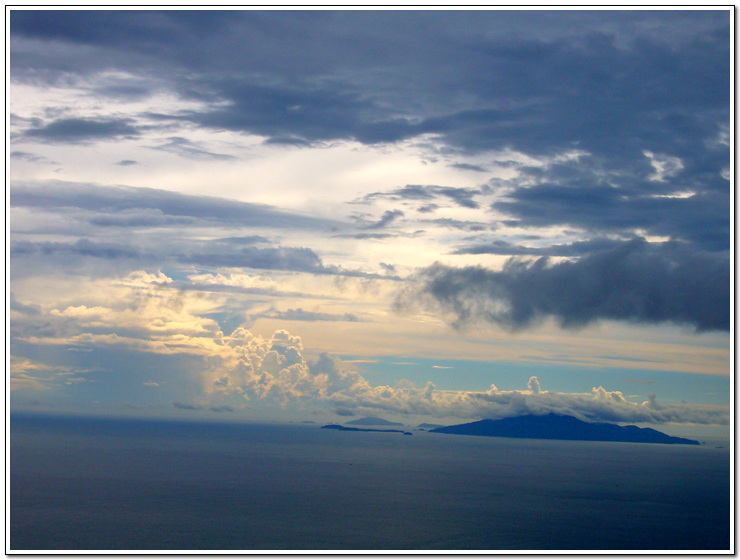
[10,181,382,277]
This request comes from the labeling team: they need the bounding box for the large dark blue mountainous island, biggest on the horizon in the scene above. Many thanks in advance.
[429,413,699,445]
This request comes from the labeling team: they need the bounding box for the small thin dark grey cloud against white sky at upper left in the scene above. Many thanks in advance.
[23,118,139,144]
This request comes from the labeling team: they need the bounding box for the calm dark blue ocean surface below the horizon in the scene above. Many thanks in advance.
[9,416,730,551]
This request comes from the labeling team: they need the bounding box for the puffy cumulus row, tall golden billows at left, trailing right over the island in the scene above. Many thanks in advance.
[207,329,729,425]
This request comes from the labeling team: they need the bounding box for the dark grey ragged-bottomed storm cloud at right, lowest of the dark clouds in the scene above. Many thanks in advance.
[397,239,730,331]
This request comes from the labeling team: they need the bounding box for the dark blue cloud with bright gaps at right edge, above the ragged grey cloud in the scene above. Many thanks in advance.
[493,159,730,251]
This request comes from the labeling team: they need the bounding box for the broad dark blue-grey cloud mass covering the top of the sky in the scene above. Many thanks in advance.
[11,10,730,160]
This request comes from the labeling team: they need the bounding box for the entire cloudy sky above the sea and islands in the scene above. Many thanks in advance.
[8,10,732,433]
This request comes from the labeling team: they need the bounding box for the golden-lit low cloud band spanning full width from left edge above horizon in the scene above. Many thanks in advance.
[11,271,729,425]
